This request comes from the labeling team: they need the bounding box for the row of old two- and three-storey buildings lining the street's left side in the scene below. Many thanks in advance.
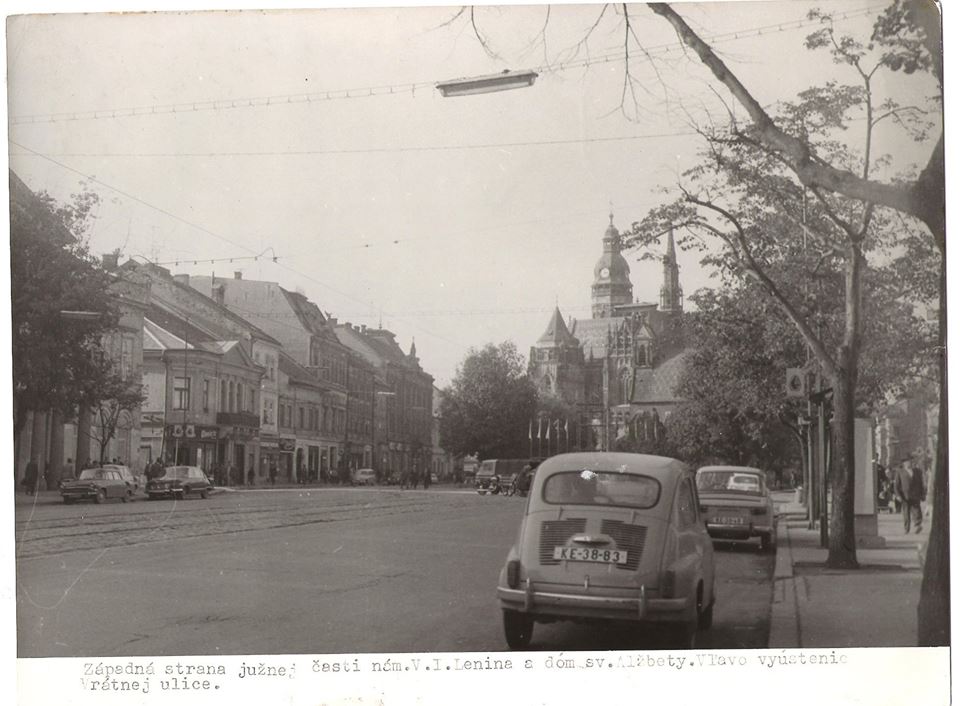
[14,177,452,484]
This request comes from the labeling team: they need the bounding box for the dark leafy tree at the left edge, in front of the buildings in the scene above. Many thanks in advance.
[10,172,118,446]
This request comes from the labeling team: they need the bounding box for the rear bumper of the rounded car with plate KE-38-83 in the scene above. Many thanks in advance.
[497,586,692,622]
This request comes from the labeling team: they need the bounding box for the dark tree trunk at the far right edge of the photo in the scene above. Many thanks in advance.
[917,251,950,647]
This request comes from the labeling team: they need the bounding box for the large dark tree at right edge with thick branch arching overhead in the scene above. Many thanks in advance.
[650,0,950,646]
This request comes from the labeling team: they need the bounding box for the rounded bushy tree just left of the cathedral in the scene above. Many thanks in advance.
[440,342,537,460]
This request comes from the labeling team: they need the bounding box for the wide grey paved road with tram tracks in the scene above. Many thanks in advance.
[16,489,773,657]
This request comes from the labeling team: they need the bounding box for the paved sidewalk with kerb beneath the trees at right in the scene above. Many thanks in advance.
[768,492,930,648]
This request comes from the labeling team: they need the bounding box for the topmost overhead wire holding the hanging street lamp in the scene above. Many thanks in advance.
[8,5,885,126]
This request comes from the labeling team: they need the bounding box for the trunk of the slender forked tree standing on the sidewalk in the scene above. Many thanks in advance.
[826,360,858,569]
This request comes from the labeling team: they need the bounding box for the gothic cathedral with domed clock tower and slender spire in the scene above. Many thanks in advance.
[530,214,685,450]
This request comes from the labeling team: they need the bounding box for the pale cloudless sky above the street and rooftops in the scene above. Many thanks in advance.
[7,0,932,387]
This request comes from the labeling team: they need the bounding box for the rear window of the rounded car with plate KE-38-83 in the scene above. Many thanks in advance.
[543,470,660,508]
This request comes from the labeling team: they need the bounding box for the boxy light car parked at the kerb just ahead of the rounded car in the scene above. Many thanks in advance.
[697,466,777,550]
